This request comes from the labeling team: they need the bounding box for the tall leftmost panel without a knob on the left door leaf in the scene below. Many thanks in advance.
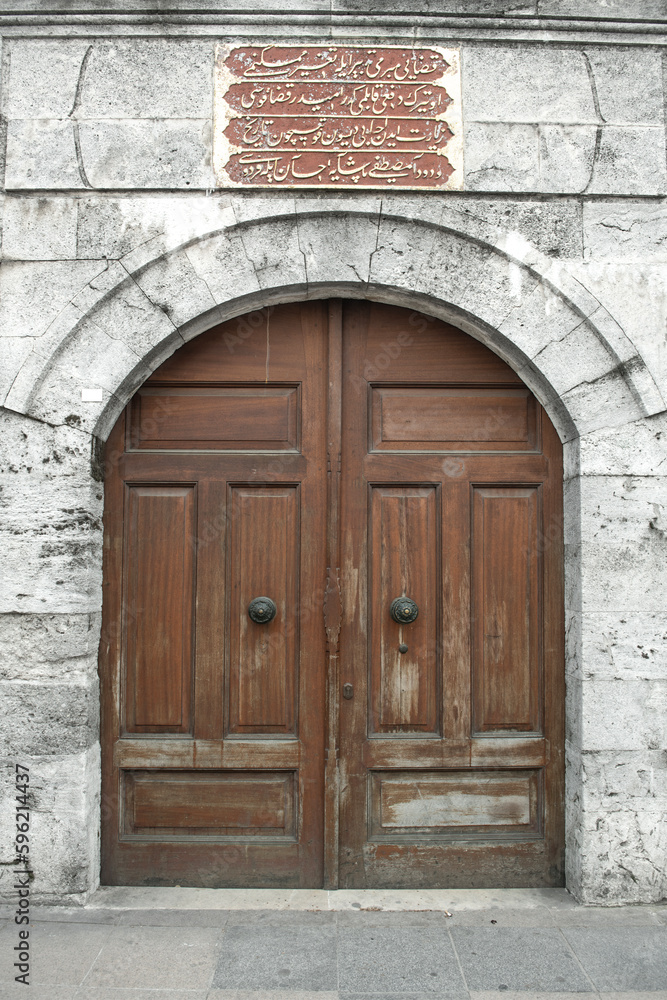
[123,485,195,733]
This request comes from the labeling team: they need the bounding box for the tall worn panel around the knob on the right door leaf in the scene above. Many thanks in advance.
[370,486,440,733]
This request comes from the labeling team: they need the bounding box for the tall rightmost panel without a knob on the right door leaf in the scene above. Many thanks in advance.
[472,486,542,733]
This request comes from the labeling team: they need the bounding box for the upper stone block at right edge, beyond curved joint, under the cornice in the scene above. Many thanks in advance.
[586,47,664,125]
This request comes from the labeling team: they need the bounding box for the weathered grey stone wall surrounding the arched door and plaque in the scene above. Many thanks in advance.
[0,0,667,903]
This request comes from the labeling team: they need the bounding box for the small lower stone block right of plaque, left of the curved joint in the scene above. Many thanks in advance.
[539,125,597,194]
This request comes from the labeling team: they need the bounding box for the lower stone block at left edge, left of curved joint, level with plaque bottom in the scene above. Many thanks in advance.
[5,119,86,191]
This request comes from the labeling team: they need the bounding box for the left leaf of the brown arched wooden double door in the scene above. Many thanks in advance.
[101,303,328,887]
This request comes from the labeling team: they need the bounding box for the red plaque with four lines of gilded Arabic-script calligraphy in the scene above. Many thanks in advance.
[214,44,463,190]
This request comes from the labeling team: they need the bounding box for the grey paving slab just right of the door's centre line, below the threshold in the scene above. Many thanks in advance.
[338,923,468,1000]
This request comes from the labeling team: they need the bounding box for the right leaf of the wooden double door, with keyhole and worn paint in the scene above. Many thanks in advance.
[340,302,563,888]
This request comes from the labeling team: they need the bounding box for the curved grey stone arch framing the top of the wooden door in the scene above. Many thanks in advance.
[6,203,665,442]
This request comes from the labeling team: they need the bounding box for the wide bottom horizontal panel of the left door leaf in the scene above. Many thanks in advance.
[121,770,297,840]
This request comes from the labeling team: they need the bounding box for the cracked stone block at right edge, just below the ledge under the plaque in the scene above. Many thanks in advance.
[583,201,667,264]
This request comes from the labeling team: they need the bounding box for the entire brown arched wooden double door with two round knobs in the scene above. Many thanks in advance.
[101,301,564,888]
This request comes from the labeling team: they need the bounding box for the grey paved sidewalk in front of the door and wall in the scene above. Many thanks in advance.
[0,888,667,1000]
